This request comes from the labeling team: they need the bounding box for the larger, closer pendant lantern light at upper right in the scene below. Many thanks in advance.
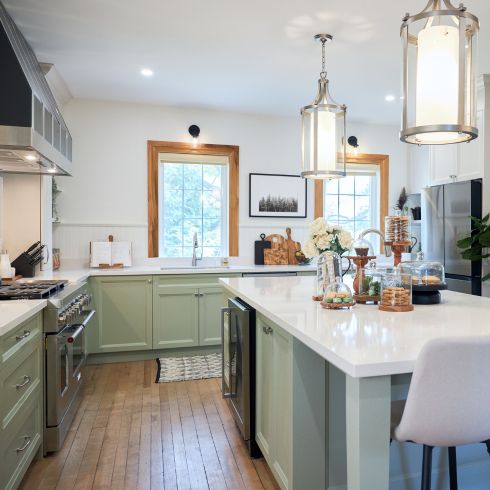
[400,0,479,145]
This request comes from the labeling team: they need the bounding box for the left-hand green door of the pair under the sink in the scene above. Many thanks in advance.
[153,284,199,349]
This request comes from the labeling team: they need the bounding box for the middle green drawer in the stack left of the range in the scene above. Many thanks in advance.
[0,337,42,429]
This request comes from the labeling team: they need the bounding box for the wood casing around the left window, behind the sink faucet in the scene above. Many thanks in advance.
[148,141,239,257]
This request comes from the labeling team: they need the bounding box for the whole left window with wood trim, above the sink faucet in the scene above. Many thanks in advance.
[148,141,238,257]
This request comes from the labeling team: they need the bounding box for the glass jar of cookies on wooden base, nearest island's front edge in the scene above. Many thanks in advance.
[379,270,413,312]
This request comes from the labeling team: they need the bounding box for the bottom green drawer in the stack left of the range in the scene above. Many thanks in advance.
[0,390,42,489]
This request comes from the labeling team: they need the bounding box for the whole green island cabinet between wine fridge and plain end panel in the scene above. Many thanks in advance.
[256,315,292,489]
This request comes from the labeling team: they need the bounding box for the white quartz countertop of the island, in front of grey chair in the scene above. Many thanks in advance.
[220,277,490,377]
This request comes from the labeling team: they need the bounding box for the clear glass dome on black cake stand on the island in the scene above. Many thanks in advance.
[399,252,447,305]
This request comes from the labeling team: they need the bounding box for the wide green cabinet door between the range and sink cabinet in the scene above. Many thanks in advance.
[87,276,153,353]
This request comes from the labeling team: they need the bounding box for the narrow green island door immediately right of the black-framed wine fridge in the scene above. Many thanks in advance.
[255,317,274,461]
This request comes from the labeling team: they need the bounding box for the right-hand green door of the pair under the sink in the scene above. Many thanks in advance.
[199,286,225,345]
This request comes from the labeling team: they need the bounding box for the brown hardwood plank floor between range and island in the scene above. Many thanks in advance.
[20,361,279,490]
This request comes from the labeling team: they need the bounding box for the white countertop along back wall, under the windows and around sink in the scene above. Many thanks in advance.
[35,265,316,283]
